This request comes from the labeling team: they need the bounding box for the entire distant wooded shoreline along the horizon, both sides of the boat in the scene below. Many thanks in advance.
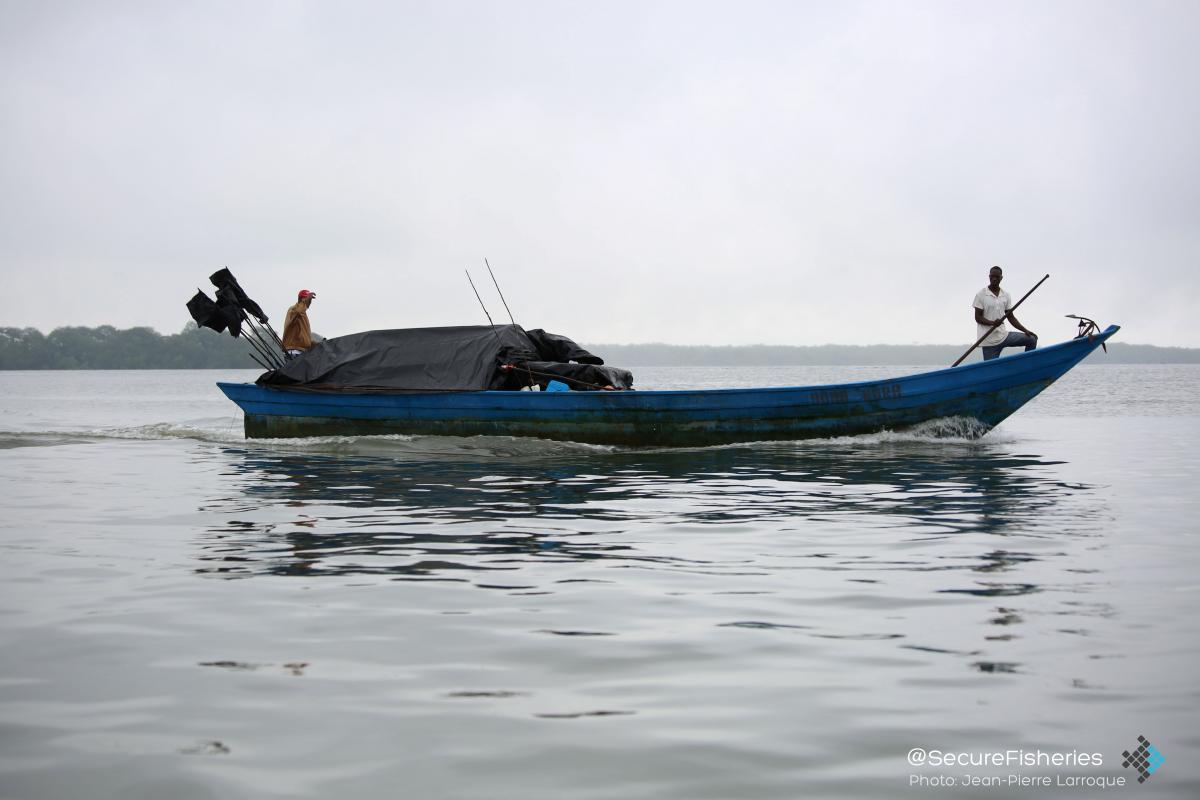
[0,323,1200,369]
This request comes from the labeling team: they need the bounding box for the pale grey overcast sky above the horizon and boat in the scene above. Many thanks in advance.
[0,0,1200,347]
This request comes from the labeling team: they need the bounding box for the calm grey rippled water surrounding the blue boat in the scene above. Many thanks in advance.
[0,367,1200,800]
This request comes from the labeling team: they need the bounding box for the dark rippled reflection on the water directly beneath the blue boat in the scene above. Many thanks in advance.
[199,437,1099,585]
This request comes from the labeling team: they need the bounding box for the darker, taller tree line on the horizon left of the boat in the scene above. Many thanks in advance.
[0,323,267,369]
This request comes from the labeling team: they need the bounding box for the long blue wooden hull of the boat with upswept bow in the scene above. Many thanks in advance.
[217,325,1120,446]
